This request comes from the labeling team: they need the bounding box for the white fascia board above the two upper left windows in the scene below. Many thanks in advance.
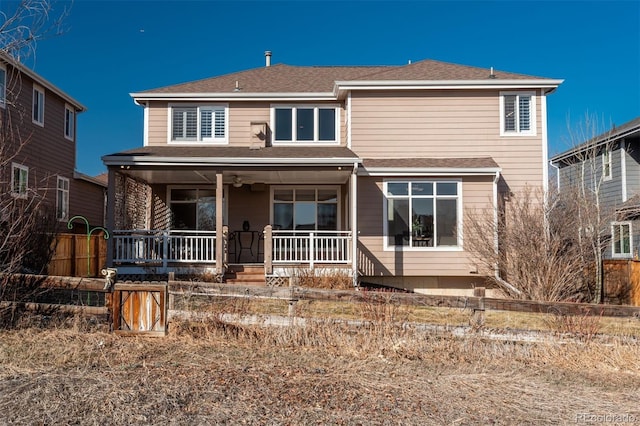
[129,92,337,103]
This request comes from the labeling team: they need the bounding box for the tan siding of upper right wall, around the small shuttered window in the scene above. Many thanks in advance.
[351,90,543,190]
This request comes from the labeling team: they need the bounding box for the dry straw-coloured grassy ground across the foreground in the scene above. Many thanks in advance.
[0,318,640,425]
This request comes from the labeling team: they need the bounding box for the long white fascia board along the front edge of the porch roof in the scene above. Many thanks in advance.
[102,155,362,167]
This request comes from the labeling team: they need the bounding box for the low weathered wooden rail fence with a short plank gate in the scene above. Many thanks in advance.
[5,277,640,336]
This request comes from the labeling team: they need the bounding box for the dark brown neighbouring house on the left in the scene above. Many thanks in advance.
[0,56,106,232]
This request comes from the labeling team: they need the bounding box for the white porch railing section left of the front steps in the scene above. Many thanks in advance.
[112,230,216,266]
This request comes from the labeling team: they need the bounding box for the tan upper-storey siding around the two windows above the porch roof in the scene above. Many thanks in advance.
[147,102,346,146]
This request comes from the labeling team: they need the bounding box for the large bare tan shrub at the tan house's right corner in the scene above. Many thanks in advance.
[464,188,593,301]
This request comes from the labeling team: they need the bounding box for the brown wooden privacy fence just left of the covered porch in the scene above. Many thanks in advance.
[47,234,107,277]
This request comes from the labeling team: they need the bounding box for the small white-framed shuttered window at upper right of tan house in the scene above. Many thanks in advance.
[500,92,536,136]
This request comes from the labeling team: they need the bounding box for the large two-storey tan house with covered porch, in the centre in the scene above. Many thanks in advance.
[103,52,562,293]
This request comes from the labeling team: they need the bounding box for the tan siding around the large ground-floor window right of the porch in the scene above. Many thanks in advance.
[358,177,493,276]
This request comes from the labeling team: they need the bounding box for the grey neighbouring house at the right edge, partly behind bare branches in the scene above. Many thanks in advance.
[551,117,640,259]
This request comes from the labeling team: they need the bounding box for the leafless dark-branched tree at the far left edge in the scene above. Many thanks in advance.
[0,0,70,325]
